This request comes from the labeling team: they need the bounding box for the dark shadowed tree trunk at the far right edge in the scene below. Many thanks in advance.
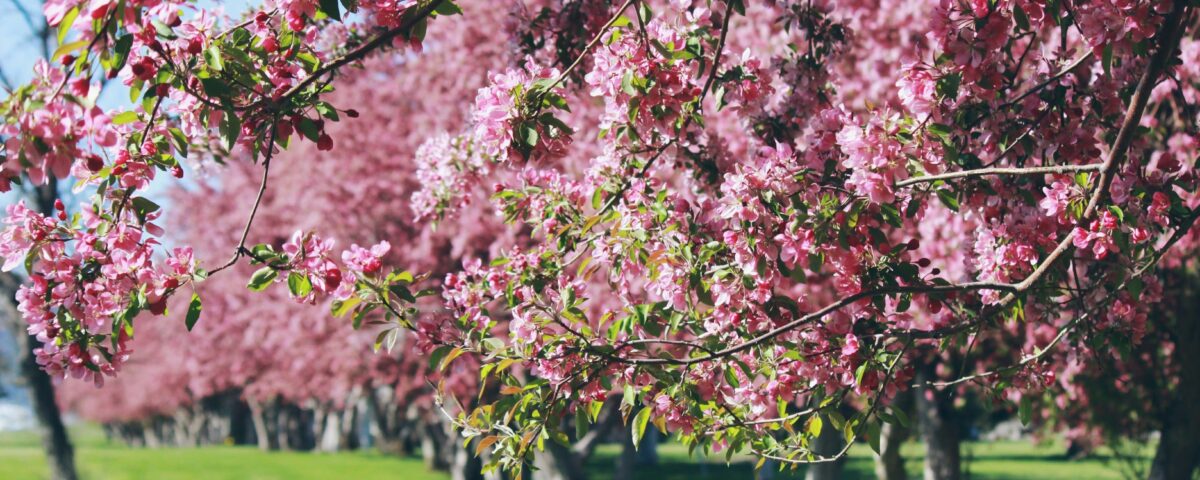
[1150,272,1200,480]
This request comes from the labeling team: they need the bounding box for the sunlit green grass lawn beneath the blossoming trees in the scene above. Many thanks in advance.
[0,426,1148,480]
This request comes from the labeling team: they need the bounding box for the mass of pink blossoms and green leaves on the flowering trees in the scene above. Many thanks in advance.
[0,0,1200,478]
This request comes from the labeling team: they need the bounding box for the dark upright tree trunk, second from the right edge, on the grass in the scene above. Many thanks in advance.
[917,360,961,480]
